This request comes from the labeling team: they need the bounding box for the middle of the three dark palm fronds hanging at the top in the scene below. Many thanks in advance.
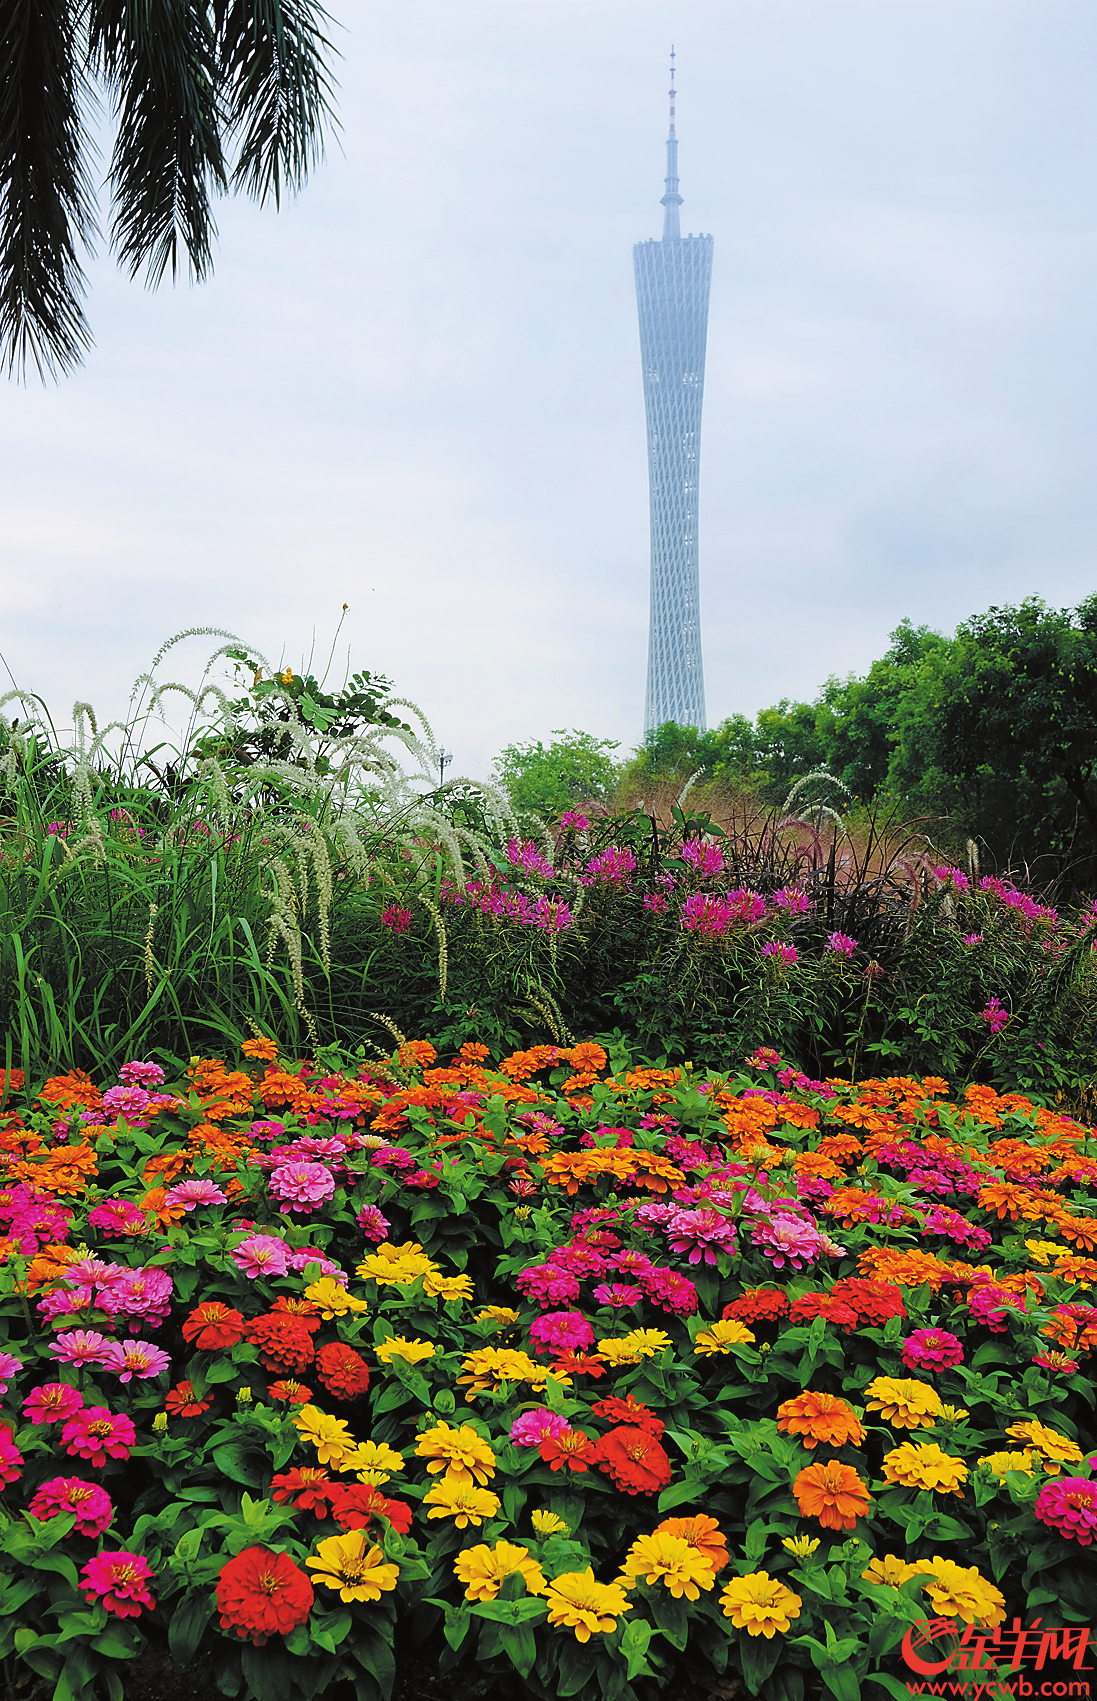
[88,0,226,282]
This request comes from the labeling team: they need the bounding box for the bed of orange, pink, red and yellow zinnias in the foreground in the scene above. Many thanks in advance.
[0,1039,1097,1701]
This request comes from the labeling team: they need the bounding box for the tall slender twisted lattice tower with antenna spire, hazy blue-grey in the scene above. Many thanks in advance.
[633,48,713,731]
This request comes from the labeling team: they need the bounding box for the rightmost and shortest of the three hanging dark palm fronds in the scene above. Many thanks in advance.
[216,0,337,206]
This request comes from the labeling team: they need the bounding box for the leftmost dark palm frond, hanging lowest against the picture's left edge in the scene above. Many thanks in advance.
[0,0,95,378]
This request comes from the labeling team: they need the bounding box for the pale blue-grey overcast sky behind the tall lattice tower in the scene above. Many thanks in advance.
[0,0,1097,777]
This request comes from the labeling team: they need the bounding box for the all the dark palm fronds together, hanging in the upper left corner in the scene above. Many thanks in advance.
[0,0,333,376]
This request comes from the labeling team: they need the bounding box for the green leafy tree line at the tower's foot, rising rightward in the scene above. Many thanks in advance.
[497,595,1097,890]
